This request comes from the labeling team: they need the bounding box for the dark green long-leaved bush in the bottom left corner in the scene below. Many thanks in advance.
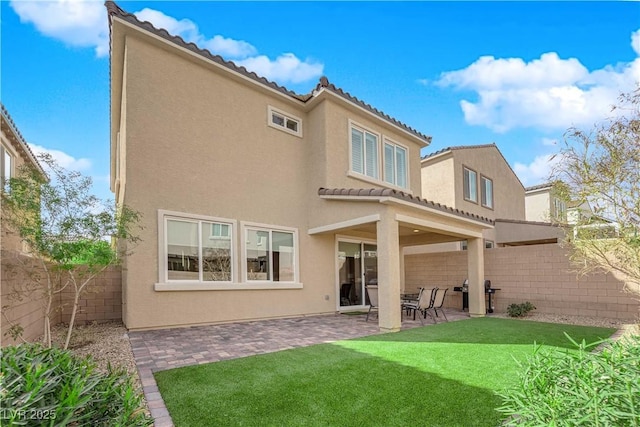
[0,344,152,426]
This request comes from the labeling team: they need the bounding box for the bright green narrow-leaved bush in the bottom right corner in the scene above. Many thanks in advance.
[498,336,640,427]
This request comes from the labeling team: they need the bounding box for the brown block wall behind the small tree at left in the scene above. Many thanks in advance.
[0,252,122,346]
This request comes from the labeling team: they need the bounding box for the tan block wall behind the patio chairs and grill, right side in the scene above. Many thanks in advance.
[404,243,640,321]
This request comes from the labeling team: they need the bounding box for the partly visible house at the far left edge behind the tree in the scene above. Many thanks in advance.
[0,104,45,253]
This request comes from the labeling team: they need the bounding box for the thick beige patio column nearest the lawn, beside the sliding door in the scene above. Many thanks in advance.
[376,209,402,332]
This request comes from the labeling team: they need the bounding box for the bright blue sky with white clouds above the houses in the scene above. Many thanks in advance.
[0,0,640,202]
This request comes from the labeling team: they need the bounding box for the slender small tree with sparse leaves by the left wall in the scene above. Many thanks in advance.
[0,154,140,348]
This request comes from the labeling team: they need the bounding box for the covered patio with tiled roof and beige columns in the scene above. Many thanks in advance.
[308,188,493,332]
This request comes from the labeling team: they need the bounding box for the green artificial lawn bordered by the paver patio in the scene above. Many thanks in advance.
[155,318,614,427]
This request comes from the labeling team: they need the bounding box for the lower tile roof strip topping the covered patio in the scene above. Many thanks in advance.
[318,187,494,225]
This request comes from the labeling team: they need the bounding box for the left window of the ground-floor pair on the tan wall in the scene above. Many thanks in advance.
[165,217,233,282]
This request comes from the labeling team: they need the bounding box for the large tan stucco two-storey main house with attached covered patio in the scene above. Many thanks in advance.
[106,2,493,330]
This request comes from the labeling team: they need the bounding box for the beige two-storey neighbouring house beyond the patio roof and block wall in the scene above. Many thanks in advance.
[404,144,563,255]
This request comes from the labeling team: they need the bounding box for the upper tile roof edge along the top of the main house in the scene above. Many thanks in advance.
[105,0,431,144]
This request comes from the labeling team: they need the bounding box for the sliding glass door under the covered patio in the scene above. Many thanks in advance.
[337,240,378,308]
